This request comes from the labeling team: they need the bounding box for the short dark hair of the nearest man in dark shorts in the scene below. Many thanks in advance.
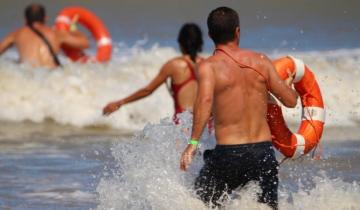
[207,7,240,44]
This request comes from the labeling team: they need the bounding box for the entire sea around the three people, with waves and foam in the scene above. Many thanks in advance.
[0,0,360,210]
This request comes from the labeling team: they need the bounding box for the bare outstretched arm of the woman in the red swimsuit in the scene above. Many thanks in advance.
[103,60,172,115]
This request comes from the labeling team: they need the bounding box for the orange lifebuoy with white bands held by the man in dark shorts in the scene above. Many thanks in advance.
[267,56,325,157]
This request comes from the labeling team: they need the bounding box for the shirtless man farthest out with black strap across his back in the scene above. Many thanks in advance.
[0,4,89,68]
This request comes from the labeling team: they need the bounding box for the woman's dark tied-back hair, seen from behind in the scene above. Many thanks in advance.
[178,23,204,62]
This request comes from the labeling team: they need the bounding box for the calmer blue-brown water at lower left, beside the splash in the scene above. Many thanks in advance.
[0,126,118,209]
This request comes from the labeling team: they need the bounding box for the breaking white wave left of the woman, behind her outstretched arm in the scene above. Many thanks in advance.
[0,46,176,129]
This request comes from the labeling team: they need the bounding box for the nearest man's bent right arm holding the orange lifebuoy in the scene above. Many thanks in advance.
[263,54,298,108]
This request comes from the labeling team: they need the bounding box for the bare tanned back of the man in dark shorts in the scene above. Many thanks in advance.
[203,45,296,145]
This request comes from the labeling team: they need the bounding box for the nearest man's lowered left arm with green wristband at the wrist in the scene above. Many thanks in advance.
[180,62,215,171]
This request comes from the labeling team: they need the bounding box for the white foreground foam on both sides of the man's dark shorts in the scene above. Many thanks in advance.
[97,114,360,210]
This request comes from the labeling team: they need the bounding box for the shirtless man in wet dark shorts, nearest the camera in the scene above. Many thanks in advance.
[180,7,297,209]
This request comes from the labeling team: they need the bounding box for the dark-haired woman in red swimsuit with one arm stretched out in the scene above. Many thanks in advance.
[103,23,203,122]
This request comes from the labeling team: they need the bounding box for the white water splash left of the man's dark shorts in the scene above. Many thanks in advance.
[98,114,214,209]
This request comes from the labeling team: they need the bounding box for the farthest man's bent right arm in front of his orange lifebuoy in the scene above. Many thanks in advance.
[57,31,90,49]
